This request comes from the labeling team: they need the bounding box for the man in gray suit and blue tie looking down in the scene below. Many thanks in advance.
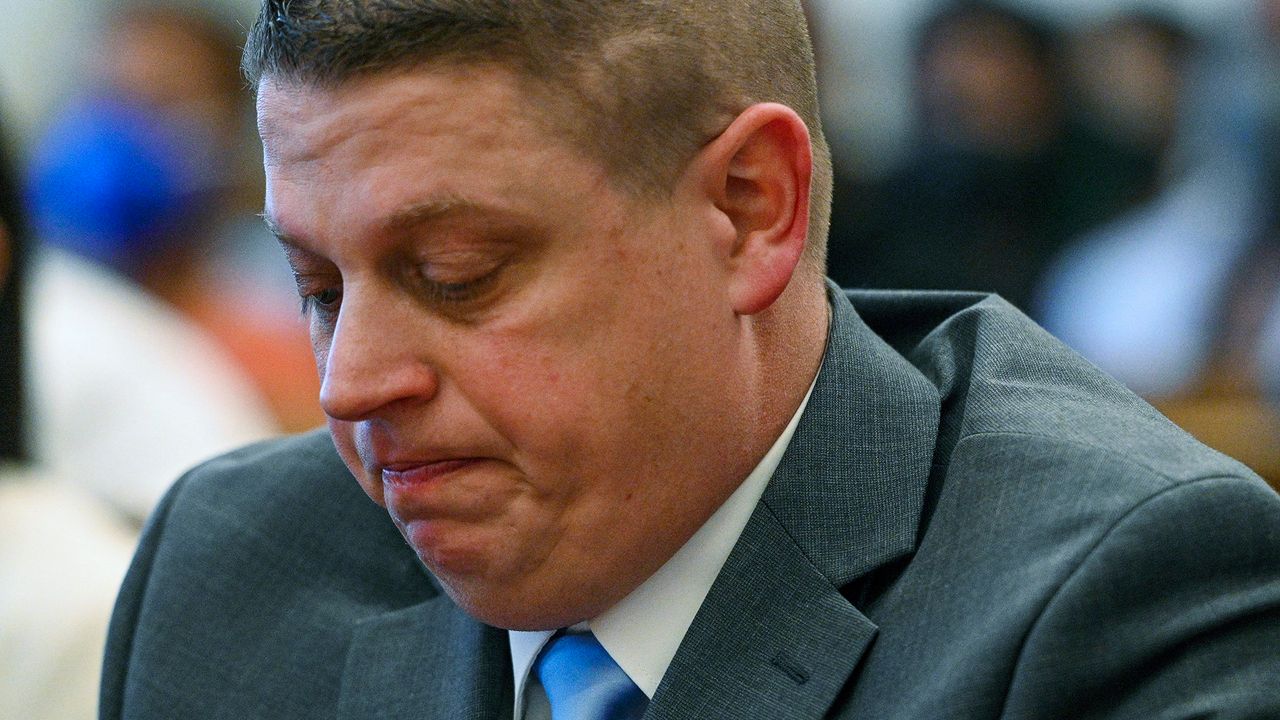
[102,0,1280,720]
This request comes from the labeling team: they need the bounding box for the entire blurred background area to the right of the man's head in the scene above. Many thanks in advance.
[809,0,1280,487]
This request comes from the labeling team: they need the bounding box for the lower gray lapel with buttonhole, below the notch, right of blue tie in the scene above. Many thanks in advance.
[645,506,876,720]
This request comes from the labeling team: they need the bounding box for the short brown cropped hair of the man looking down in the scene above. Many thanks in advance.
[243,0,832,272]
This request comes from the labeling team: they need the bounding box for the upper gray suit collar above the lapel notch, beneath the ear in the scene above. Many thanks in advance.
[763,280,941,587]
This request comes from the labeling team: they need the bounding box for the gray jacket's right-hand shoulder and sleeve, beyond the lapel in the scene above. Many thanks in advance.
[839,293,1280,719]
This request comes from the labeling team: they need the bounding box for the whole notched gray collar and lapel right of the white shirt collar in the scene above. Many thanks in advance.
[646,288,940,720]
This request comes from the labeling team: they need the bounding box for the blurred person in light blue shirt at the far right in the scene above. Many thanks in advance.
[1036,13,1280,487]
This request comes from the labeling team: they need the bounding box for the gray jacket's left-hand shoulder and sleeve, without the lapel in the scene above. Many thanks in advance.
[101,433,436,719]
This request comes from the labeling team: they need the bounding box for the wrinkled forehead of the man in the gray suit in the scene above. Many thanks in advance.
[257,68,640,249]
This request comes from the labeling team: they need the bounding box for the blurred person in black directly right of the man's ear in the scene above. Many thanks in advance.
[829,1,1153,309]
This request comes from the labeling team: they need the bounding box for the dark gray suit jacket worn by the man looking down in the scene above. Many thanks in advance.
[101,292,1280,720]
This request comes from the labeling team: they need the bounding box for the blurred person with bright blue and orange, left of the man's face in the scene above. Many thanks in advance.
[29,3,323,430]
